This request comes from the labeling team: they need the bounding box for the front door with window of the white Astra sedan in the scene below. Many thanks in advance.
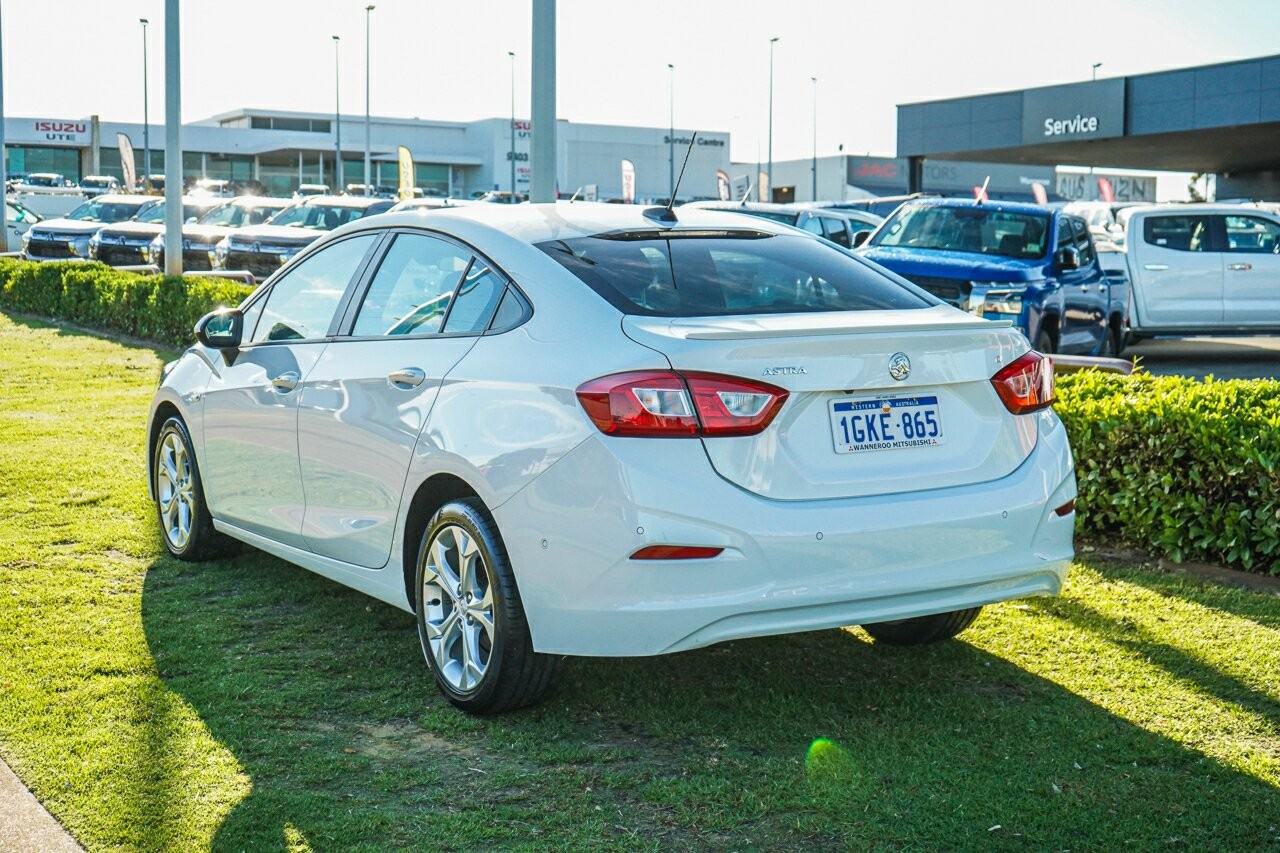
[201,234,378,547]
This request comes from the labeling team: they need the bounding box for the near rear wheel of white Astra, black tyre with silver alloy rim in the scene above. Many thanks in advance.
[415,498,564,713]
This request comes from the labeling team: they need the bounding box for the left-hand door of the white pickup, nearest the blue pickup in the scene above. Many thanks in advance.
[1128,211,1224,329]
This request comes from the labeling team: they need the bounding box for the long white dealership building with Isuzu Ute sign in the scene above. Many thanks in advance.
[5,109,728,201]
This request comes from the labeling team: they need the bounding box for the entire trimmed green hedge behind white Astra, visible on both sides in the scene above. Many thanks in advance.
[0,259,1280,575]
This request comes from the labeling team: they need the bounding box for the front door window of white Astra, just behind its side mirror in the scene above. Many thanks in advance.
[245,234,378,343]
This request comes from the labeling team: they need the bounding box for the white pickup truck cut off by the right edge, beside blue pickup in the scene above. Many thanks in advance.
[1125,204,1280,339]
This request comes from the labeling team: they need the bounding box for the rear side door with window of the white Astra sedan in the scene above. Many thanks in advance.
[298,231,506,569]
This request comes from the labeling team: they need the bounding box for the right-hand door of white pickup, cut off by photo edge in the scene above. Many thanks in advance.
[1215,214,1280,328]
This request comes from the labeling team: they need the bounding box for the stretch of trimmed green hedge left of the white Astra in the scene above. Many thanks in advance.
[0,259,253,347]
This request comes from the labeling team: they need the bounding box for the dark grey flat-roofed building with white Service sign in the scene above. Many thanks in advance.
[897,55,1280,199]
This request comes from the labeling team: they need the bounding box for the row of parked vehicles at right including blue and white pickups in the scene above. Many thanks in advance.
[685,197,1280,356]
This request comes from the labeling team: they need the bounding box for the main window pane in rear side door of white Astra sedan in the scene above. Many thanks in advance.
[351,233,471,337]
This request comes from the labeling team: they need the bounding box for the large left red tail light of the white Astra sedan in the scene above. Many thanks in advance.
[577,370,788,438]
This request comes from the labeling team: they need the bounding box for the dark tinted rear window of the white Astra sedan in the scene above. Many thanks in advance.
[538,231,932,316]
